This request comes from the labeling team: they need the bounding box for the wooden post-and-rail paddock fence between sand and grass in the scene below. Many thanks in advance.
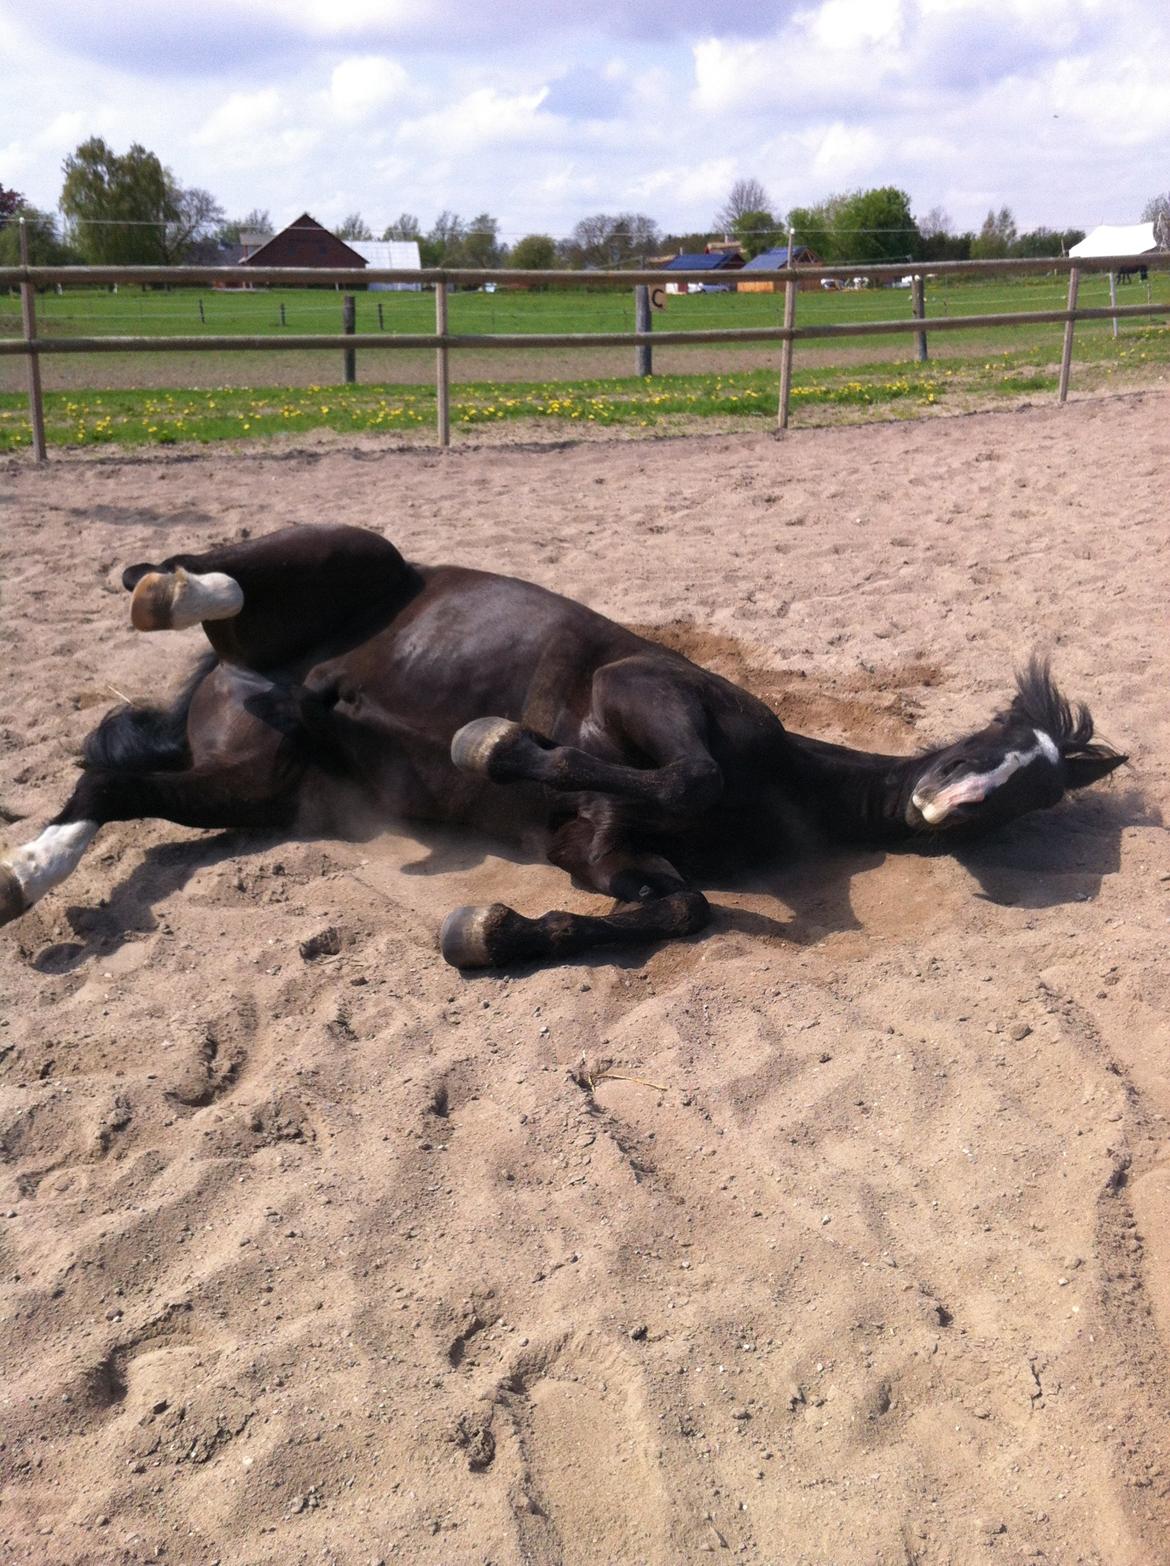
[0,250,1170,462]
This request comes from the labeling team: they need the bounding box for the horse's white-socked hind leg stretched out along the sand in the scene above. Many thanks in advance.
[0,758,296,924]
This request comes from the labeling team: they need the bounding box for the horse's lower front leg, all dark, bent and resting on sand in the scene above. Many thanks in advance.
[439,810,711,968]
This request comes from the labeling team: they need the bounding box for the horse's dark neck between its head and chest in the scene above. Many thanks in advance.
[785,731,924,843]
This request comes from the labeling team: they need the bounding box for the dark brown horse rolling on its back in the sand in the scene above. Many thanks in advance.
[0,526,1125,968]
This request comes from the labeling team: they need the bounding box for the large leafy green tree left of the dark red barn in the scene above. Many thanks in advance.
[61,136,180,266]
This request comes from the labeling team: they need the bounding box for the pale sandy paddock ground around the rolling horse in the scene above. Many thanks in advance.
[0,393,1170,1566]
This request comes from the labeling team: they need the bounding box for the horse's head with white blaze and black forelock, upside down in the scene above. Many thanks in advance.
[905,656,1128,832]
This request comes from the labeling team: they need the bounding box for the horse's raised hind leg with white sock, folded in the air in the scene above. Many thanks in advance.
[122,526,420,669]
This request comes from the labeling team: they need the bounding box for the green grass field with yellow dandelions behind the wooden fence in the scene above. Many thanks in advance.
[0,274,1170,451]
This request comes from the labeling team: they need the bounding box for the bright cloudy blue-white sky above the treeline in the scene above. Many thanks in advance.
[0,0,1170,243]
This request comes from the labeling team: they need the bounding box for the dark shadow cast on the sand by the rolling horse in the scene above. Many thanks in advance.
[34,788,1162,974]
